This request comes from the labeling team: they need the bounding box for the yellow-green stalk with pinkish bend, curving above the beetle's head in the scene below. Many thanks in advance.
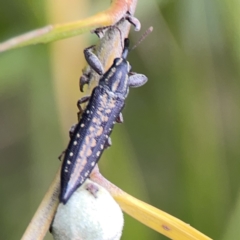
[0,0,136,52]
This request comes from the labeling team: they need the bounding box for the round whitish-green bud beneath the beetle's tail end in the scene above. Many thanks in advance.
[51,179,124,240]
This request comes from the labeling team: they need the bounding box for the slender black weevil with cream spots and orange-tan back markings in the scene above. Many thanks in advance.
[60,39,147,204]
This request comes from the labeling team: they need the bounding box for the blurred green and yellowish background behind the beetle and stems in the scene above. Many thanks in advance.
[0,0,240,240]
